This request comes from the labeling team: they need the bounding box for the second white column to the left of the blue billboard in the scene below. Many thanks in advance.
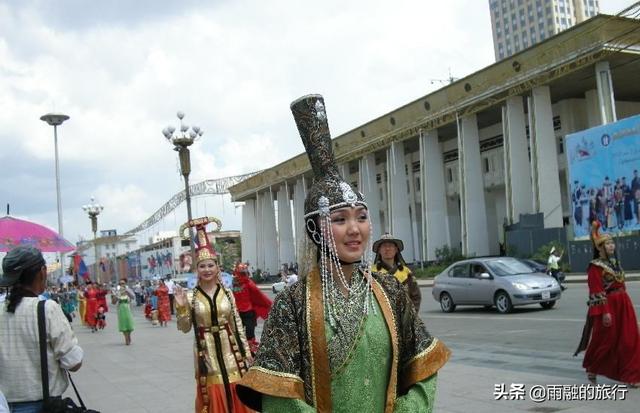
[502,96,533,224]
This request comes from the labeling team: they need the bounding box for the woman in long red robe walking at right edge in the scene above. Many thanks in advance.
[575,221,640,387]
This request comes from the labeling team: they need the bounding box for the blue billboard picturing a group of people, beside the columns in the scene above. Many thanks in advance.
[566,115,640,239]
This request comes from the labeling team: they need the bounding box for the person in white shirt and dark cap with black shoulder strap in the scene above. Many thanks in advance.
[0,246,84,413]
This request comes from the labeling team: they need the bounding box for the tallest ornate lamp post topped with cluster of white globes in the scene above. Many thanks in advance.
[162,112,204,262]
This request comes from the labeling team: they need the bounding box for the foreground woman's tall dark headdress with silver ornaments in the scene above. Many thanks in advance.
[291,95,367,245]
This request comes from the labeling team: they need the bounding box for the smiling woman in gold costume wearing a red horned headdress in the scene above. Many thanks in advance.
[175,217,253,413]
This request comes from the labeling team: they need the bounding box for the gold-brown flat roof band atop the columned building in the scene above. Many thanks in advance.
[229,14,640,201]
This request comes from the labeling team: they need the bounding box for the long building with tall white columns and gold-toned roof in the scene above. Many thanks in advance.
[230,15,640,270]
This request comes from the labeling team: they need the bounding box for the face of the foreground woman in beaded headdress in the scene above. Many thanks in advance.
[330,206,370,263]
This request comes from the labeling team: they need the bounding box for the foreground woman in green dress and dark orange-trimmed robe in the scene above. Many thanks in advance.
[238,95,450,413]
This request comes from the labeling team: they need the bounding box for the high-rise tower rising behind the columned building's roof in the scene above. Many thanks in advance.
[489,0,599,60]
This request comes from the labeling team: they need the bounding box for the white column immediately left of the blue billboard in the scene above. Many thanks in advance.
[529,86,562,228]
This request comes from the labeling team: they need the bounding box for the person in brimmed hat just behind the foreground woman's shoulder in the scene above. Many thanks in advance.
[371,233,422,312]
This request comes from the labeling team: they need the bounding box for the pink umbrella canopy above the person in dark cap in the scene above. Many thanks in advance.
[0,216,76,252]
